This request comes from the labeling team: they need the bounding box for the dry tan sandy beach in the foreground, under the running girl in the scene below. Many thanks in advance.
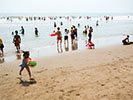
[0,45,133,100]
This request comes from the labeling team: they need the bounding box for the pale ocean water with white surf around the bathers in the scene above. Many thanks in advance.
[0,15,133,61]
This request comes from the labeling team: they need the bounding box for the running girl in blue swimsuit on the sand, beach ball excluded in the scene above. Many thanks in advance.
[19,51,32,79]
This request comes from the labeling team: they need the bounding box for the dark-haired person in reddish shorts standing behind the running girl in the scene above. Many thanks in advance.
[13,30,21,52]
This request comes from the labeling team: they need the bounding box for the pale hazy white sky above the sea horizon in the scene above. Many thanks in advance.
[0,0,133,13]
